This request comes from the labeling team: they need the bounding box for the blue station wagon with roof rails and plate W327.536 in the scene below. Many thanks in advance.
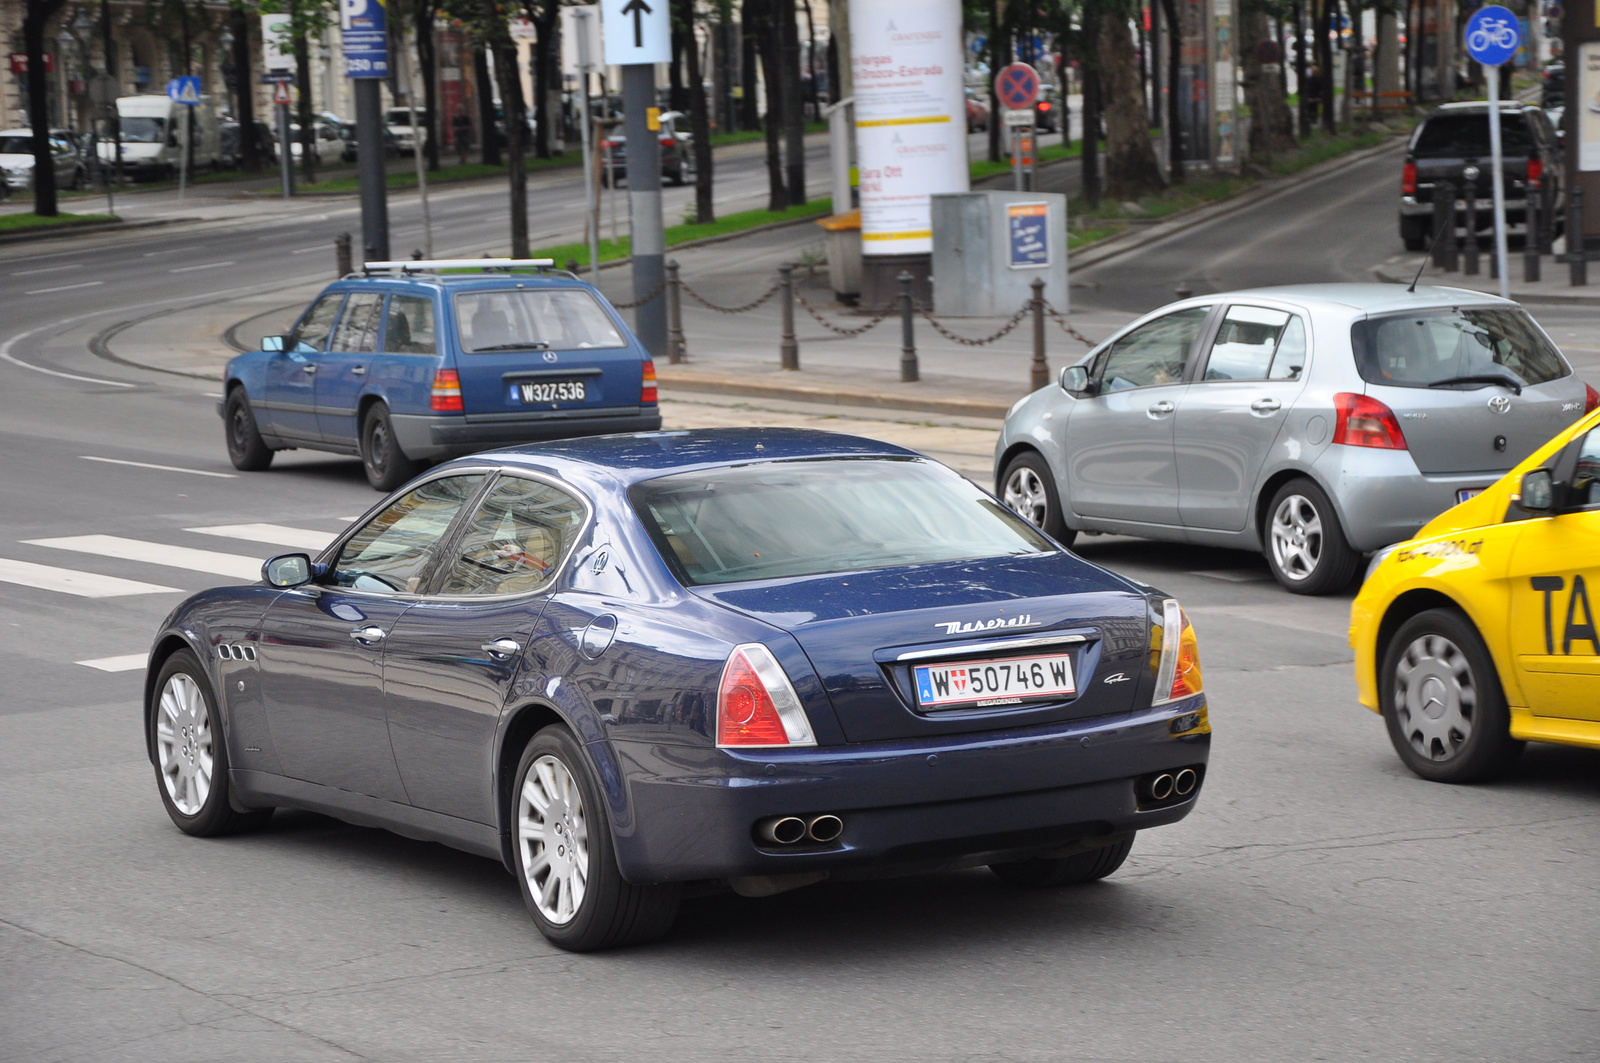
[218,259,661,491]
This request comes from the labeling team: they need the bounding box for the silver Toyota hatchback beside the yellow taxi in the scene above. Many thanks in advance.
[995,283,1600,594]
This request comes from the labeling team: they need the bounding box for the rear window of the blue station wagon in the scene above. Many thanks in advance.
[456,288,627,354]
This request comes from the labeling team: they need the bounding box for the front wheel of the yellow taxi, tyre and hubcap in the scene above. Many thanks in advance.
[1379,608,1523,783]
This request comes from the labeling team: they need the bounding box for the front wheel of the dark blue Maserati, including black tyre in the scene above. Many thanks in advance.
[149,650,272,837]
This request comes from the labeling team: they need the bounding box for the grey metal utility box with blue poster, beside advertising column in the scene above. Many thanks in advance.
[931,192,1067,317]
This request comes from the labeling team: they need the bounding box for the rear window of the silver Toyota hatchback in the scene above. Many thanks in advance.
[1350,307,1570,387]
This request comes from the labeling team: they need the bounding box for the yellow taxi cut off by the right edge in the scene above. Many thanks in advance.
[1350,410,1600,783]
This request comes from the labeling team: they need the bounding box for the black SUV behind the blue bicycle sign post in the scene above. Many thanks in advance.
[1400,101,1566,251]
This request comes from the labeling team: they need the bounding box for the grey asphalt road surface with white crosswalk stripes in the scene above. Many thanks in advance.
[0,143,1600,1063]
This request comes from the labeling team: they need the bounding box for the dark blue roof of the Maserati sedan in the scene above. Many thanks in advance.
[451,427,922,485]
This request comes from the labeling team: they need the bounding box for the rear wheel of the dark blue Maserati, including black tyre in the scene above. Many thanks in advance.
[512,725,680,953]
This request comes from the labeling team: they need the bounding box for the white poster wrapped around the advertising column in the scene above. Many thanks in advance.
[850,0,968,255]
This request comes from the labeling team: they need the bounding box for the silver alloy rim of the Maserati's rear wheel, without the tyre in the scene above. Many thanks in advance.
[517,754,589,925]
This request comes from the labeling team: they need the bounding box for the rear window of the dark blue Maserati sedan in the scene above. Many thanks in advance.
[629,458,1054,586]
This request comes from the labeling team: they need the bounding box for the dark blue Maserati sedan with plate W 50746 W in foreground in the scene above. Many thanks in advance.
[144,429,1211,949]
